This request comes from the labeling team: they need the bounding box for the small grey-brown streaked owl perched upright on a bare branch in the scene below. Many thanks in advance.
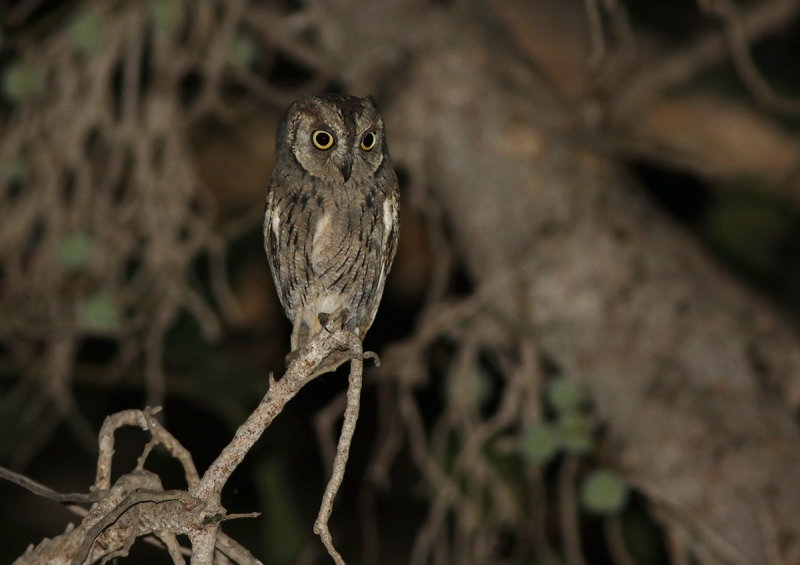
[264,94,399,359]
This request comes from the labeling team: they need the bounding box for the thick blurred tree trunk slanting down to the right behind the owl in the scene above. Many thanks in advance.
[310,2,800,563]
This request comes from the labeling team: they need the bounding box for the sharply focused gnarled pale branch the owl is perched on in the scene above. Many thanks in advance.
[7,324,368,565]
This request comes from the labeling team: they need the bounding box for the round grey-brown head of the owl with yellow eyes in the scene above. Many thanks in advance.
[276,94,388,182]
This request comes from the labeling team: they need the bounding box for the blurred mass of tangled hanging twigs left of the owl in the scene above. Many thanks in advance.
[0,0,332,466]
